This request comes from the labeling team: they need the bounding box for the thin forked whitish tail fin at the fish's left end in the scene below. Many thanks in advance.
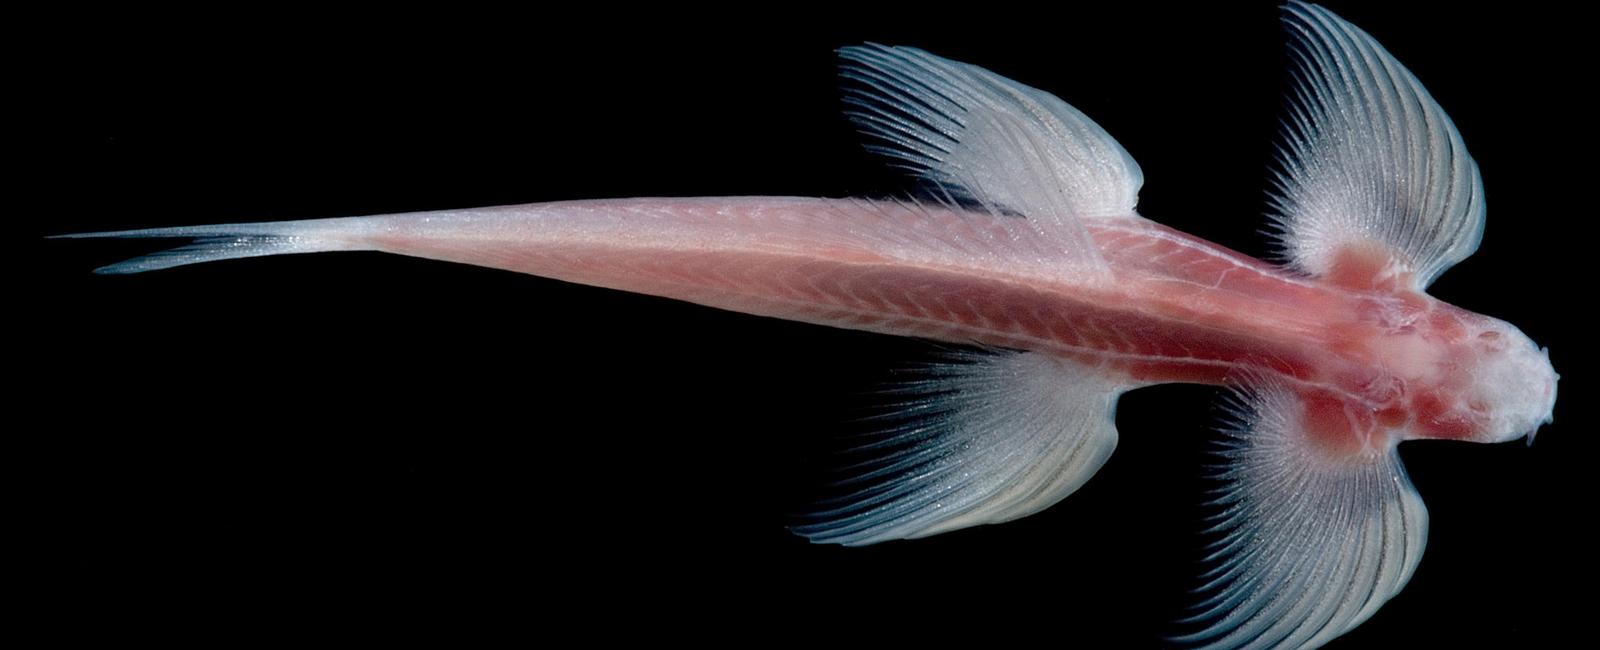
[50,219,373,275]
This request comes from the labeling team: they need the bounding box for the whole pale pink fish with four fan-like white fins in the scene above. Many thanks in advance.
[59,5,1555,647]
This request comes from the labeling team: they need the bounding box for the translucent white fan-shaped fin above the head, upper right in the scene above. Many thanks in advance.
[1272,2,1485,290]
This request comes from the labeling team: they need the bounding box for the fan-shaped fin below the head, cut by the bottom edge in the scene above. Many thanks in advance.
[1173,386,1427,648]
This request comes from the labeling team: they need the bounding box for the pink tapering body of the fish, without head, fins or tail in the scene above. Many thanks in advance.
[350,197,1470,451]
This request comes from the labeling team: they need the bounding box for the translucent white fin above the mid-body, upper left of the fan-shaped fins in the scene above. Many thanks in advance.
[840,45,1144,269]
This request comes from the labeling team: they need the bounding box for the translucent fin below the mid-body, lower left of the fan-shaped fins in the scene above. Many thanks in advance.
[794,352,1126,546]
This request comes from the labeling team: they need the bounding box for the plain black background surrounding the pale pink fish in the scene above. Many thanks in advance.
[34,3,1594,647]
